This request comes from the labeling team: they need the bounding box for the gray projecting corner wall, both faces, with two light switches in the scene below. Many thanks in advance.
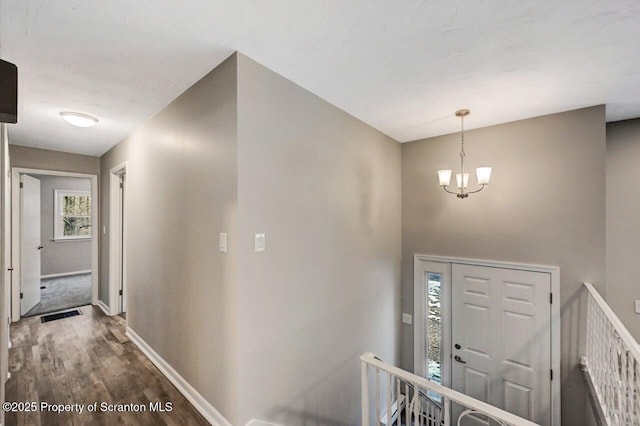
[100,51,401,425]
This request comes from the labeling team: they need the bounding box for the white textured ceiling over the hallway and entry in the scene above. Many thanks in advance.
[0,0,640,155]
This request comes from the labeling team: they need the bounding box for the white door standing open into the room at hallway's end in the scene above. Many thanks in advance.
[20,175,42,315]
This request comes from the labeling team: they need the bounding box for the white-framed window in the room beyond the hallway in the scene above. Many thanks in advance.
[54,189,91,240]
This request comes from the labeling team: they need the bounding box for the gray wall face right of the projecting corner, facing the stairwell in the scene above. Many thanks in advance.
[237,55,401,426]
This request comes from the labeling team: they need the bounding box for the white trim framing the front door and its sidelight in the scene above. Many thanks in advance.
[413,254,561,425]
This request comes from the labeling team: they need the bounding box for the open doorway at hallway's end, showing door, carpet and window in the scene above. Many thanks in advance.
[11,168,98,322]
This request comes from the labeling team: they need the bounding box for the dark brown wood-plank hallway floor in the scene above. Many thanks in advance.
[5,306,209,426]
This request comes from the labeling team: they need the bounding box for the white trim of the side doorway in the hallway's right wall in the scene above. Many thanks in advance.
[109,161,129,315]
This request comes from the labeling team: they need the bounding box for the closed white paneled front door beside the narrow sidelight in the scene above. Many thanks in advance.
[451,264,551,425]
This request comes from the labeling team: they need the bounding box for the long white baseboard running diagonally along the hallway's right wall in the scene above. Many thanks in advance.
[127,327,231,426]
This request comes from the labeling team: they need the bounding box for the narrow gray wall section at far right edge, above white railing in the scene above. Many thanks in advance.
[607,120,640,341]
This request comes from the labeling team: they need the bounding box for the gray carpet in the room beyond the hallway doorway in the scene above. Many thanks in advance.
[24,274,92,317]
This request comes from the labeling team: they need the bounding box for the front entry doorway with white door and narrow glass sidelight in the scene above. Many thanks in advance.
[414,255,560,425]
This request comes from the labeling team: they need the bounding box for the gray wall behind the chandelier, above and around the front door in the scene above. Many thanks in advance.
[402,106,606,425]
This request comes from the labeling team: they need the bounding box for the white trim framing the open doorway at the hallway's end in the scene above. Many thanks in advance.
[11,167,100,322]
